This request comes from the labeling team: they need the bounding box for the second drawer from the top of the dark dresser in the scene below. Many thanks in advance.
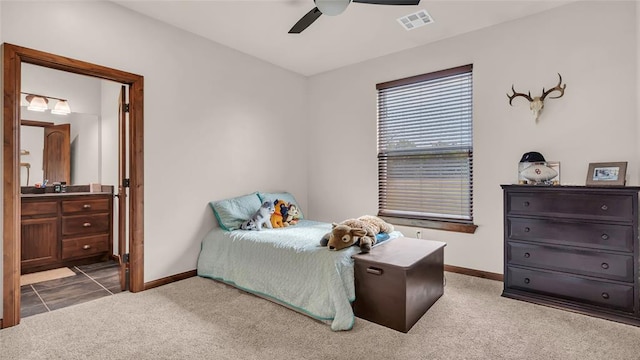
[506,218,634,252]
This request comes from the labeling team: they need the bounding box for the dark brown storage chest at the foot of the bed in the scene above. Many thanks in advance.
[351,237,446,333]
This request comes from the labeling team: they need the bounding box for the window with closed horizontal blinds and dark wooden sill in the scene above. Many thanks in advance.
[377,65,476,232]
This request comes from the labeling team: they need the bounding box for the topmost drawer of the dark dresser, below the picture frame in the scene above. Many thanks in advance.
[506,191,634,222]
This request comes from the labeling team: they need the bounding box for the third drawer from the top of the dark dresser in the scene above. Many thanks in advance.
[507,242,634,283]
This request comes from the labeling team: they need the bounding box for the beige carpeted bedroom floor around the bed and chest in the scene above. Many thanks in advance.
[0,273,640,360]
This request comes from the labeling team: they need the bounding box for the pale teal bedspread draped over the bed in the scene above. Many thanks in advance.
[198,220,401,330]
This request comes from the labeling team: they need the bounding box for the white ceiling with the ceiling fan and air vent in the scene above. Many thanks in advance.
[114,0,575,76]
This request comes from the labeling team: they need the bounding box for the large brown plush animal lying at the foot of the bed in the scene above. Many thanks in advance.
[320,215,393,252]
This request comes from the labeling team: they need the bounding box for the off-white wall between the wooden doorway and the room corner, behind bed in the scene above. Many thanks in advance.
[0,1,307,290]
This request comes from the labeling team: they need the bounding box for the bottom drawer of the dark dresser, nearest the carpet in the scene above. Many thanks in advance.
[505,267,634,312]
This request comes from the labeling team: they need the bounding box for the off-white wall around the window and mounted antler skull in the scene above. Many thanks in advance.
[308,1,639,273]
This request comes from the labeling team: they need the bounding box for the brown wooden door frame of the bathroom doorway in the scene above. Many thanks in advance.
[0,43,144,328]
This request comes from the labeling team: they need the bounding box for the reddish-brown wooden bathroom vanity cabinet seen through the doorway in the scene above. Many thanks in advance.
[21,186,113,274]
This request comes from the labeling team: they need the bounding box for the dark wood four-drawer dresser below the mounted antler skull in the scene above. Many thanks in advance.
[502,185,640,326]
